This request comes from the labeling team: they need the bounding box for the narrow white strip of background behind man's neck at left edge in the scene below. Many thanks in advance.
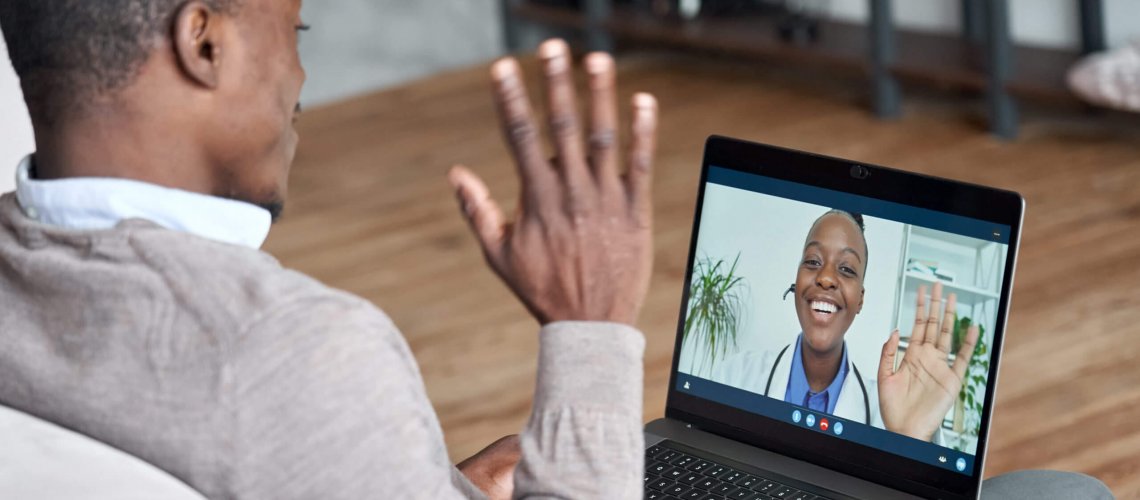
[0,38,34,192]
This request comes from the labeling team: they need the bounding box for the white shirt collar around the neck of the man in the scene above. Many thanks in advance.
[16,156,272,249]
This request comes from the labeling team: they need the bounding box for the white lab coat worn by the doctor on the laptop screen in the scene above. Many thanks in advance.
[710,344,945,445]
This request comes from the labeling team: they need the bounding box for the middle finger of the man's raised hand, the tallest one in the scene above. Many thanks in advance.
[538,39,586,189]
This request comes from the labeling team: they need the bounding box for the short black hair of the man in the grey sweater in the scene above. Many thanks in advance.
[0,0,238,118]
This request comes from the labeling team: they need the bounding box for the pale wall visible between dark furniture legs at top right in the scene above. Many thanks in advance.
[829,0,1140,48]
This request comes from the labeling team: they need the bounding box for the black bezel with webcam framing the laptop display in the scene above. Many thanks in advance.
[666,136,1025,499]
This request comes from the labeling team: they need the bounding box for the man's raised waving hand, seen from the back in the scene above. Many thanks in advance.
[448,40,658,325]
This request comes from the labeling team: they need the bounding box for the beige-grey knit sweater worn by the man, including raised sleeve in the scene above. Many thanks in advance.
[0,195,644,499]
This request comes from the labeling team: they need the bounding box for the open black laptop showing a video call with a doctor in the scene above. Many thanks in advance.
[645,137,1025,500]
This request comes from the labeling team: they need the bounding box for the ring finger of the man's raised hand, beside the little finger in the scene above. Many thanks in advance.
[586,52,618,186]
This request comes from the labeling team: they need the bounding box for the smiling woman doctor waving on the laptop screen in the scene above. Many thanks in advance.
[713,210,978,444]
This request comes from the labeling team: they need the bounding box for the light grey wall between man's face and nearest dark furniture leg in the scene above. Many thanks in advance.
[301,0,503,105]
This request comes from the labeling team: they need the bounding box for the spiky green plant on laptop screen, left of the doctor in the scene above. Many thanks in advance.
[682,253,748,375]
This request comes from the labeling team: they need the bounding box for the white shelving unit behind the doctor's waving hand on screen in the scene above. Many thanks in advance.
[894,226,1008,452]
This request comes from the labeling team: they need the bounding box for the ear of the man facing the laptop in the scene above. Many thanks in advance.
[173,0,222,89]
